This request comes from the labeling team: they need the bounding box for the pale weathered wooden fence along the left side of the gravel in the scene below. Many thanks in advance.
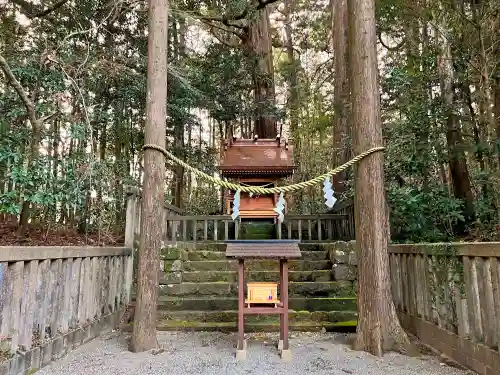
[0,246,133,375]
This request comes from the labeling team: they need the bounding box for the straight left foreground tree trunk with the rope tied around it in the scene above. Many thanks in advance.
[131,0,168,352]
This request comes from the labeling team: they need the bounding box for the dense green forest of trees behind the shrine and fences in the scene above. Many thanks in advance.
[0,0,500,242]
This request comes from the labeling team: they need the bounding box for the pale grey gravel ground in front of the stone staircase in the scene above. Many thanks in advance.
[37,332,469,375]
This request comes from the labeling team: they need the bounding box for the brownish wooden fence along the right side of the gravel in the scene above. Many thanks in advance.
[389,243,500,375]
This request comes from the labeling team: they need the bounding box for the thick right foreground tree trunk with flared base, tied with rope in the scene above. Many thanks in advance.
[348,0,409,356]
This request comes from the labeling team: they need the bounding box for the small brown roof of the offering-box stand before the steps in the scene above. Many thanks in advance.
[226,240,301,259]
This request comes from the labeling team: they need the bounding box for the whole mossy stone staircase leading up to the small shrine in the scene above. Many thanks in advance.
[154,242,356,332]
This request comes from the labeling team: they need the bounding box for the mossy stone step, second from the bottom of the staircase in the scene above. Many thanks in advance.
[158,310,357,324]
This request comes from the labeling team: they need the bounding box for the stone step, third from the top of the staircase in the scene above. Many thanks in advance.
[164,260,332,272]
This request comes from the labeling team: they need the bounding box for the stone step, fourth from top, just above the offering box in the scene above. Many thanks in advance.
[160,270,333,284]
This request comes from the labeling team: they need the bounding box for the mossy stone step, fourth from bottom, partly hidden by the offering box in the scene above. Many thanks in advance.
[160,281,355,297]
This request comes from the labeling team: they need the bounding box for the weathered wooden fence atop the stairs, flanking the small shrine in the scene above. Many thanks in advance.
[126,190,354,242]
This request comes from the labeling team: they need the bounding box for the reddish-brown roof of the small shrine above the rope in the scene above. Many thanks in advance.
[219,139,295,176]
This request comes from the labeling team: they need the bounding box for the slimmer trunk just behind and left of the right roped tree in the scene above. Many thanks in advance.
[332,0,350,193]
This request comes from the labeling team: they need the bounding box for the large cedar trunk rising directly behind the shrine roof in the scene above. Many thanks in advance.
[243,7,277,138]
